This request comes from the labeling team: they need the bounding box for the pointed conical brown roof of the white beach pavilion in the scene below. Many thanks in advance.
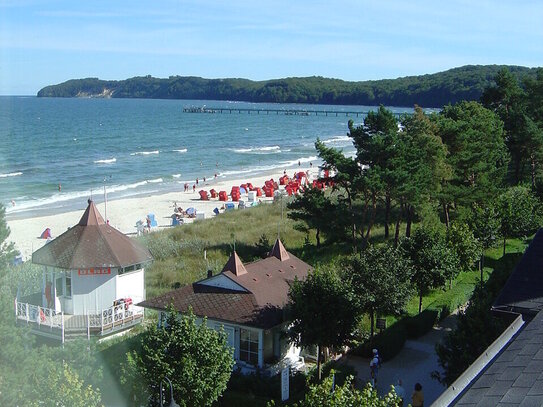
[32,201,152,270]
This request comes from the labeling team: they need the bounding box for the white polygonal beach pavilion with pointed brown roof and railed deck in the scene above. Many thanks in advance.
[16,200,152,341]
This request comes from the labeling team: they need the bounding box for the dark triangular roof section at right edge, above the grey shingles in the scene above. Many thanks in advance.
[493,229,543,315]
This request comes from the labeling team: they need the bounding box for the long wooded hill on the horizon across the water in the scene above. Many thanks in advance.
[38,65,536,107]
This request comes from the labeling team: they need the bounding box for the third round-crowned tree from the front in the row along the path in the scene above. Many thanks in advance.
[400,228,458,314]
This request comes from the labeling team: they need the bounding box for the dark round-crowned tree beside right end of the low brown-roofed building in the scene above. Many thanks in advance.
[287,268,358,380]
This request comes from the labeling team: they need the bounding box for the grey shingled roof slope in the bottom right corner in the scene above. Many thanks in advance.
[454,311,543,407]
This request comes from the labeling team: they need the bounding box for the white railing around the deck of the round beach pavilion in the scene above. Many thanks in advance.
[15,299,143,342]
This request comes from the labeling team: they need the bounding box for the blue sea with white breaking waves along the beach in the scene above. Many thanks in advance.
[0,96,411,219]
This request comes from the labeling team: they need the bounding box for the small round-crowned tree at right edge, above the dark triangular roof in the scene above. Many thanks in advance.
[496,186,541,255]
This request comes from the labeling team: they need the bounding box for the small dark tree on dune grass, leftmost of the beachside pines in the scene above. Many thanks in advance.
[287,186,331,247]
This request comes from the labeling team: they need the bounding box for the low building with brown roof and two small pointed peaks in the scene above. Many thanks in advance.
[140,240,312,373]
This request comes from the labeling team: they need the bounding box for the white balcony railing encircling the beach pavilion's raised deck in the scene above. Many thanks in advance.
[15,299,143,343]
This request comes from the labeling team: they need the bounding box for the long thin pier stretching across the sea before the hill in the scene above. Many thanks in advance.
[183,106,412,118]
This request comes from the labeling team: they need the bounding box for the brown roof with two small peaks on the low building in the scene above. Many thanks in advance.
[139,242,311,329]
